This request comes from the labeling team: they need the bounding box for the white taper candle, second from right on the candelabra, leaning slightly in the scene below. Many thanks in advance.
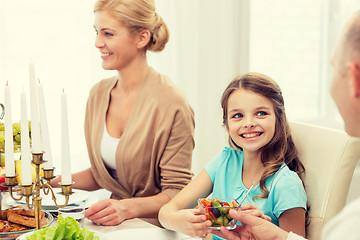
[37,81,53,169]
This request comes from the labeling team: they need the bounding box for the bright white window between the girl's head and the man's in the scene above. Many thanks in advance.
[249,0,358,128]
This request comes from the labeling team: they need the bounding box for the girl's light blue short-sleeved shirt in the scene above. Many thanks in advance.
[205,147,307,226]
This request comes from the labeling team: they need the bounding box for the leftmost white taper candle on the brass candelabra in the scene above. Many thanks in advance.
[5,82,15,177]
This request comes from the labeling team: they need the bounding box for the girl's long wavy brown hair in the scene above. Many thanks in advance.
[221,72,305,198]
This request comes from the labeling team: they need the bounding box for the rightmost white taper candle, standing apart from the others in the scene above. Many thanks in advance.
[61,90,72,184]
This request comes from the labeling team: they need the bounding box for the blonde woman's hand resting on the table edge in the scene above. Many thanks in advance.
[85,199,132,226]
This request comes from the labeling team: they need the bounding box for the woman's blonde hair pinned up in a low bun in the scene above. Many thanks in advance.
[94,0,169,52]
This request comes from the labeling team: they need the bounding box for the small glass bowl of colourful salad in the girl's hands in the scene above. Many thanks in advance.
[198,198,238,230]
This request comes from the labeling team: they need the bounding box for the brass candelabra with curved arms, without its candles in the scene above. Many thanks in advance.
[2,152,74,230]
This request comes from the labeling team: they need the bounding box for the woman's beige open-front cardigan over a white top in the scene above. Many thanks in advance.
[85,69,195,199]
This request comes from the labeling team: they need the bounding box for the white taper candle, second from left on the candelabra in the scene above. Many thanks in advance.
[21,90,32,185]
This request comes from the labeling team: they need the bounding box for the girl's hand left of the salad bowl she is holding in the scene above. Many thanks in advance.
[172,209,212,237]
